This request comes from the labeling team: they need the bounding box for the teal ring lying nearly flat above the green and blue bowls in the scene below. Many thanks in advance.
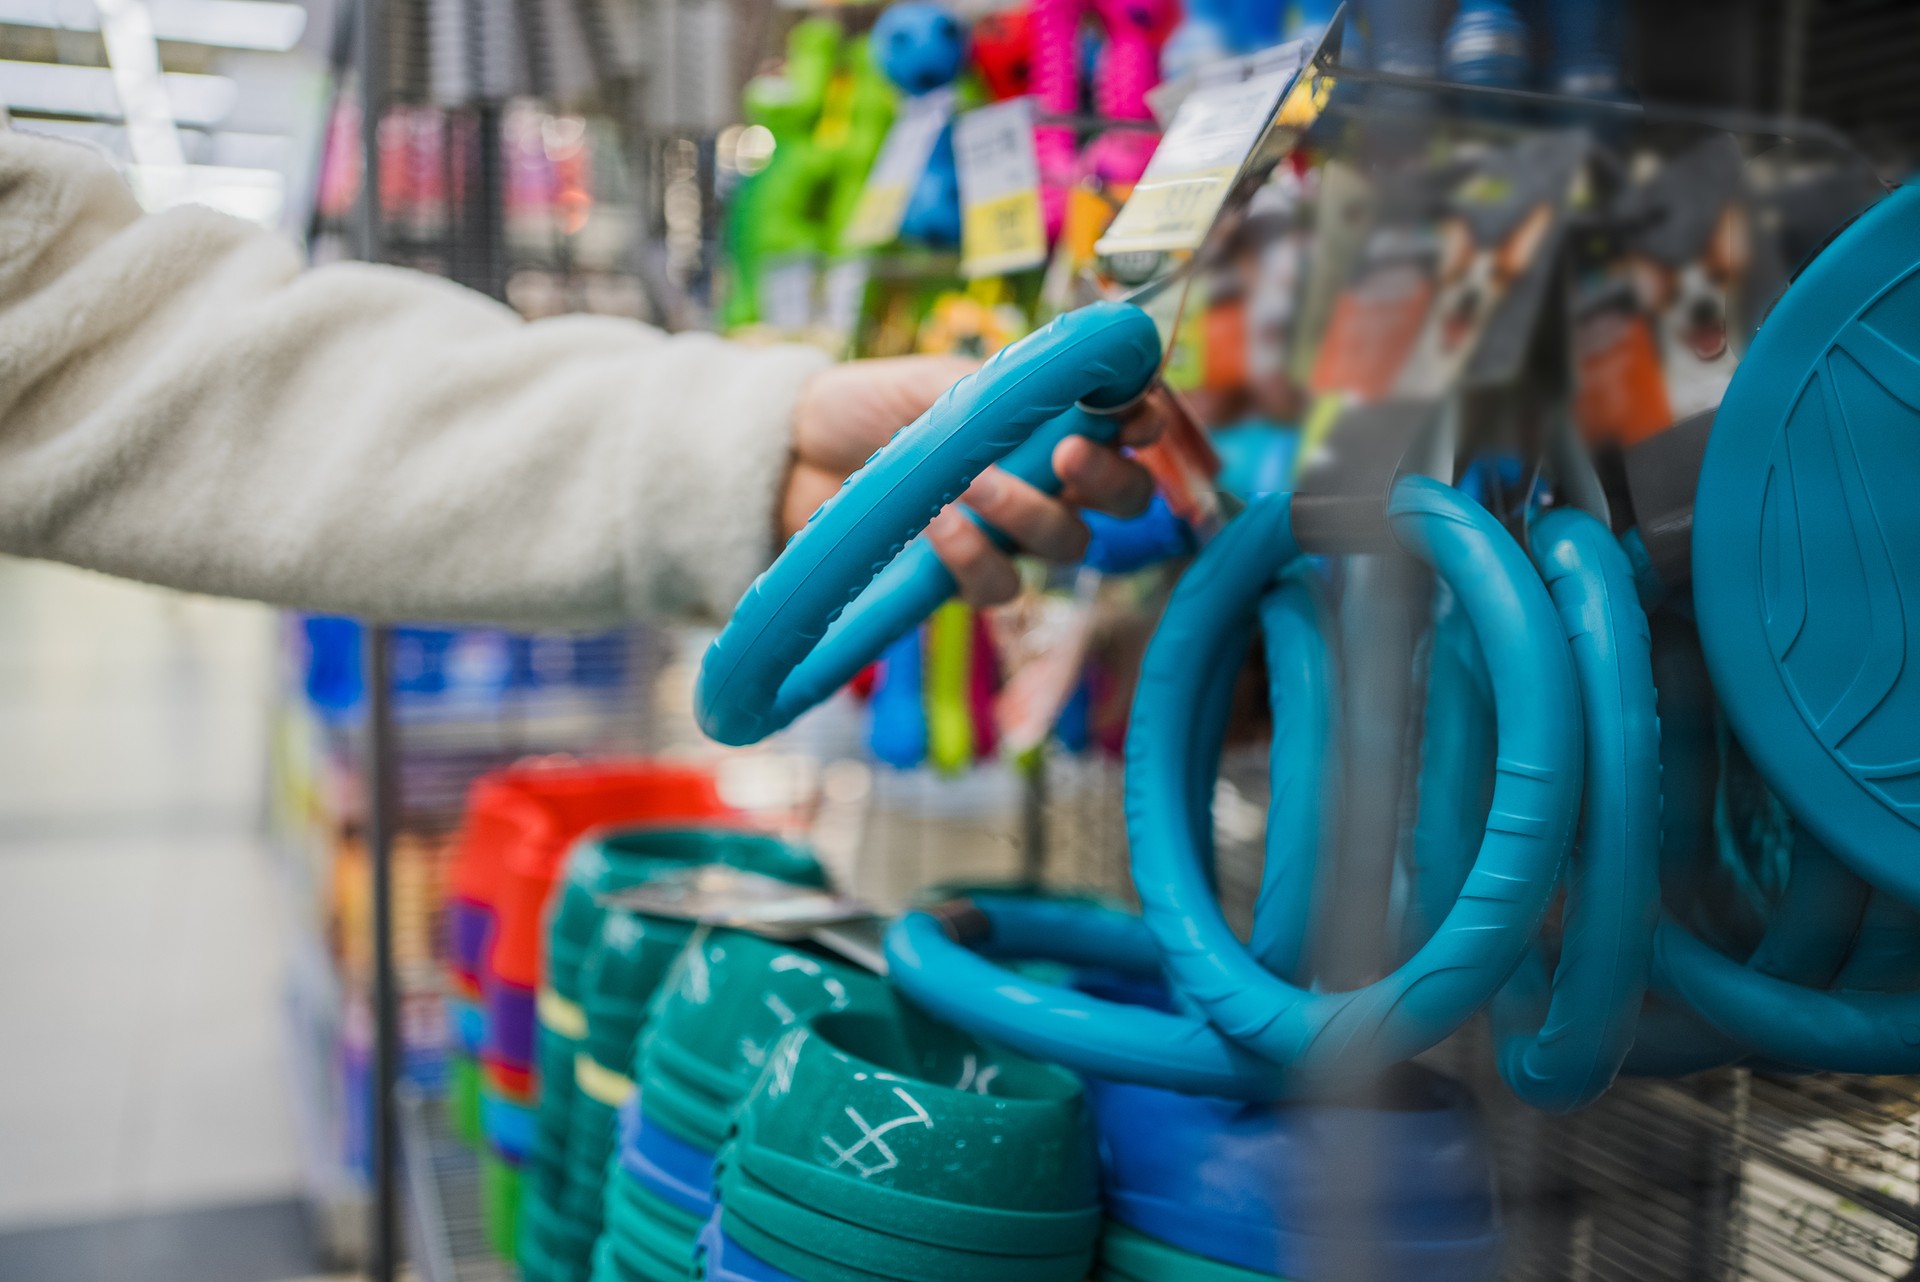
[887,894,1286,1100]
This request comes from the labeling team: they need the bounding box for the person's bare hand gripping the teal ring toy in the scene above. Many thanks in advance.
[780,357,1165,605]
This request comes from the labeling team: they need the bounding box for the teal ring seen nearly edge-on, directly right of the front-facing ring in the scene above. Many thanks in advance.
[1492,509,1661,1113]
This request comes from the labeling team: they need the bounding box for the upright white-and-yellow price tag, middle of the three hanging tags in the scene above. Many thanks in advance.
[954,98,1046,276]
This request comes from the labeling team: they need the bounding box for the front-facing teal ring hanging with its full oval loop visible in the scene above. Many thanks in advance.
[1127,476,1582,1088]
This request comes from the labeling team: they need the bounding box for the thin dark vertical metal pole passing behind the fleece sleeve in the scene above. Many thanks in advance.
[353,0,399,1282]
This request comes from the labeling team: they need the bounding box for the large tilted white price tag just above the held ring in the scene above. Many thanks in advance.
[1096,69,1298,255]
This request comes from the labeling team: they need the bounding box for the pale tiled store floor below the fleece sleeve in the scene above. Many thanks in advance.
[0,560,330,1282]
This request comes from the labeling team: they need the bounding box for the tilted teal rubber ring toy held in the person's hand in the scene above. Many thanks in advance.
[693,303,1160,747]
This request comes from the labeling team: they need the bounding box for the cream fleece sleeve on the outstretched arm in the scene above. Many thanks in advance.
[0,127,826,624]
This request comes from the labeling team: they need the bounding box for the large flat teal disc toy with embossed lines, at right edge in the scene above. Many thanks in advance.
[1693,188,1920,908]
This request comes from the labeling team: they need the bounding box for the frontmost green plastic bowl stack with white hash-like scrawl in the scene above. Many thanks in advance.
[707,1008,1102,1282]
